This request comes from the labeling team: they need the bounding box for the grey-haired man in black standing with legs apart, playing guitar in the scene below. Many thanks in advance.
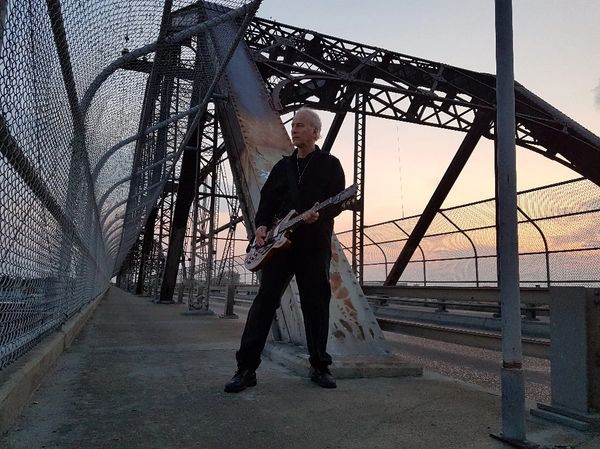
[225,108,345,392]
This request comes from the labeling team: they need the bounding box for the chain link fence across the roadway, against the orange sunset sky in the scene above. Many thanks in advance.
[337,178,600,287]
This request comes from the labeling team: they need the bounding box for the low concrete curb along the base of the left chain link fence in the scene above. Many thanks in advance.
[0,289,108,433]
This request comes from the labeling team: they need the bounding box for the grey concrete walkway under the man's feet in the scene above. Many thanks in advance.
[0,288,600,449]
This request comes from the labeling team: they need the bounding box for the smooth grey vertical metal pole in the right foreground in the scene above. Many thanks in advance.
[496,0,525,441]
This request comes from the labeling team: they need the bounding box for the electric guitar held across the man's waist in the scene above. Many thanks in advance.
[244,184,358,271]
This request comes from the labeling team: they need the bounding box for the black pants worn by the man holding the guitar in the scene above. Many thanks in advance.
[236,244,331,370]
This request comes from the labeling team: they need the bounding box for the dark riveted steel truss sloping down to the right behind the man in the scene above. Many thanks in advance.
[119,12,600,290]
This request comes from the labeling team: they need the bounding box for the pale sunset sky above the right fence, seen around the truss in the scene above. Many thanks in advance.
[257,0,600,231]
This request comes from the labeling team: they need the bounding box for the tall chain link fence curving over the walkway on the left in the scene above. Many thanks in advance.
[0,0,260,368]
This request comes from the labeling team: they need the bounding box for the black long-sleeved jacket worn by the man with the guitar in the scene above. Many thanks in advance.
[255,147,345,251]
